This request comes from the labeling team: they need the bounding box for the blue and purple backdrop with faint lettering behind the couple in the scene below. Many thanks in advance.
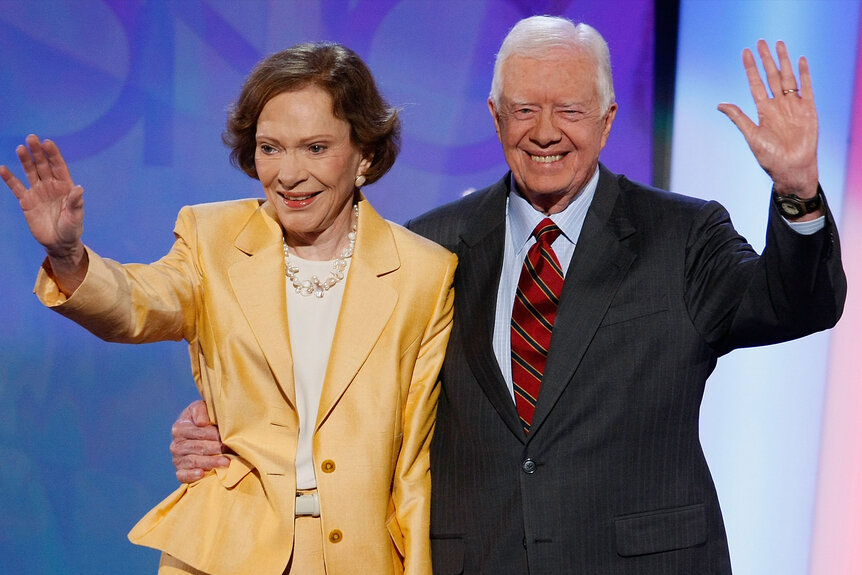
[0,0,653,575]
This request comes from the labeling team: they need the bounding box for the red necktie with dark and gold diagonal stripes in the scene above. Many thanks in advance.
[512,218,563,433]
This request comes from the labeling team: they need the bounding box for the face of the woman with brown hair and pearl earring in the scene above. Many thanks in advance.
[254,86,371,259]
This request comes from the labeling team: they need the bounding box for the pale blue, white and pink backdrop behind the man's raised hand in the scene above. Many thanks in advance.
[671,0,862,575]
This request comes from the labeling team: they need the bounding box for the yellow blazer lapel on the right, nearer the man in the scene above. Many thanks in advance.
[317,198,401,428]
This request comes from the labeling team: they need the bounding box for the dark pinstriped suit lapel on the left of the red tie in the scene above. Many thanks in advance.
[454,182,524,439]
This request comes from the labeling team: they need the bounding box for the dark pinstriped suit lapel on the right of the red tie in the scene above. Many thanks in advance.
[530,166,637,437]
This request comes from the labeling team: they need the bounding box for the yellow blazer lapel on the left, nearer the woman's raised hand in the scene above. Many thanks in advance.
[228,202,296,409]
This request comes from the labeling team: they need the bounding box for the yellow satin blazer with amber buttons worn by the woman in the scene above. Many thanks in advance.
[36,199,456,575]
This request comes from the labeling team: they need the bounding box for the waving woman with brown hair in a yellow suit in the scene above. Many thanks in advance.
[0,44,456,575]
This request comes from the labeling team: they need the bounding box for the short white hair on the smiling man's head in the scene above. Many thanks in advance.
[490,16,614,114]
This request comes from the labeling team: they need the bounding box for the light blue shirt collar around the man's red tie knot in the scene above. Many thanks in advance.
[507,166,599,252]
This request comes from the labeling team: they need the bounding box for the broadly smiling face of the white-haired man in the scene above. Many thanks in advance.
[488,48,617,214]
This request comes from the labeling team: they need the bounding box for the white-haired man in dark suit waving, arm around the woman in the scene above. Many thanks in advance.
[172,17,846,575]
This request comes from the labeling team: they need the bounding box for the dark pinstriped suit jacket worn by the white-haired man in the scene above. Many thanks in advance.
[410,166,846,575]
